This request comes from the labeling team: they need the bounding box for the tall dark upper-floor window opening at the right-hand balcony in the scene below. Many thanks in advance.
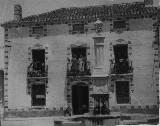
[113,44,129,73]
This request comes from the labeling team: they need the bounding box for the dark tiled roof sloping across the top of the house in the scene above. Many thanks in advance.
[1,2,158,27]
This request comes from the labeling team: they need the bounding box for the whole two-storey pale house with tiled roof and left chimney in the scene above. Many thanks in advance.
[2,2,159,115]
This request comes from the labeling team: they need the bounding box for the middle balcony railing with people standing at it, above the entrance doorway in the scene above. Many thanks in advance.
[67,58,91,76]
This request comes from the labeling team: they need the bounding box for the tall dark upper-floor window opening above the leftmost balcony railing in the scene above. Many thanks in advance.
[32,49,45,72]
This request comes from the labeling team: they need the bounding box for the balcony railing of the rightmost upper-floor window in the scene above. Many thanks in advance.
[110,59,133,74]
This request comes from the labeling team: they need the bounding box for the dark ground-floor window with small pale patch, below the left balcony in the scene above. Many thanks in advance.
[32,84,46,106]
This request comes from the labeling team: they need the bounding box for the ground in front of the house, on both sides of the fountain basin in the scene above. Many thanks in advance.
[1,113,159,126]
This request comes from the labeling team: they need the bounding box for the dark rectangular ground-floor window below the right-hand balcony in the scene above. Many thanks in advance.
[116,81,130,104]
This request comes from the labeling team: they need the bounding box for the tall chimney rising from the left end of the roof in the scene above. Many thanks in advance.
[14,4,22,20]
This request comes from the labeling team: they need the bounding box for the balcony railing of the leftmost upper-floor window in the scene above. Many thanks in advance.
[27,64,48,77]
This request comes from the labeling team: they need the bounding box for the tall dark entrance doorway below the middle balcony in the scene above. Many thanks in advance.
[72,85,89,115]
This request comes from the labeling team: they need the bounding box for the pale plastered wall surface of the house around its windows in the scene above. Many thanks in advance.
[4,18,158,112]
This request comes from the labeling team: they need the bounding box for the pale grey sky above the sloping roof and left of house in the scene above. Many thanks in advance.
[0,0,152,69]
